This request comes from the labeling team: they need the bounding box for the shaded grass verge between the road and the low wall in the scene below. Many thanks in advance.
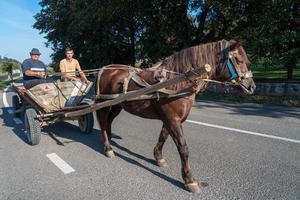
[197,92,300,107]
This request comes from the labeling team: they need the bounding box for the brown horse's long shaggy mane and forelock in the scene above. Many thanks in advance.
[156,40,249,73]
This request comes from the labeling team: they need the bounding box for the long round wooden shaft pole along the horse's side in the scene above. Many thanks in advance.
[65,64,211,117]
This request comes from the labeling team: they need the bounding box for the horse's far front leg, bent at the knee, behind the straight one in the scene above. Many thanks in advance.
[153,125,169,167]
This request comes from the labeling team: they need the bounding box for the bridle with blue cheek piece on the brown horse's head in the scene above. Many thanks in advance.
[220,48,253,83]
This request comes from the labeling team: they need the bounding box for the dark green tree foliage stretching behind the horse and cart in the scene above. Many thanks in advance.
[34,0,300,79]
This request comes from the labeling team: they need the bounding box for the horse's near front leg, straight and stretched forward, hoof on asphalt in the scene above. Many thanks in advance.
[168,121,200,193]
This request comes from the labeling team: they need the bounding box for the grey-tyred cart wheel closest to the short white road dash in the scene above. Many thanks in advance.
[24,108,41,145]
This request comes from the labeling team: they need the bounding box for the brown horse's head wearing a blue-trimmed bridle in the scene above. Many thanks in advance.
[217,41,256,94]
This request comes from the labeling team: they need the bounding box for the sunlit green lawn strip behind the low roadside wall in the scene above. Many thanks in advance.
[253,69,300,79]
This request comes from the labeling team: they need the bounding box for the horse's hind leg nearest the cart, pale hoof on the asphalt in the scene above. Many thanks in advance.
[96,108,114,158]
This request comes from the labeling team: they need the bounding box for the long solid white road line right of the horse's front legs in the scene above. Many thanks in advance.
[186,120,300,144]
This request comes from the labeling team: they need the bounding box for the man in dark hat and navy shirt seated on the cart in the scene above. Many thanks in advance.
[21,48,52,89]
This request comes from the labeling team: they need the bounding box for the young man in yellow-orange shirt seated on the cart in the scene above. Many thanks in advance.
[59,48,89,83]
